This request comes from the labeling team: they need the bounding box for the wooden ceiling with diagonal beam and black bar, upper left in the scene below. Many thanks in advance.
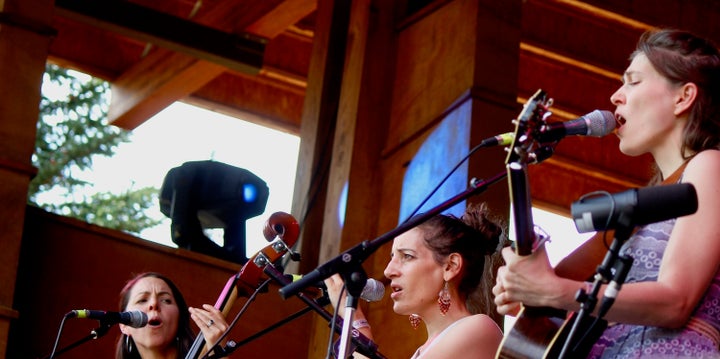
[50,0,316,133]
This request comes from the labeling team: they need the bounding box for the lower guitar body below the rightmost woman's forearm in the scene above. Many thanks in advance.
[496,307,607,359]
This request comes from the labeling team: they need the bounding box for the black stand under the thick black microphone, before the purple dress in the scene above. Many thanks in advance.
[558,217,634,359]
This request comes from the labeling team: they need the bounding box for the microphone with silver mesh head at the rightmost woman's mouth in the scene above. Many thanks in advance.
[536,110,616,142]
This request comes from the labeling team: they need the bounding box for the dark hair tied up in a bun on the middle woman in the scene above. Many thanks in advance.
[418,203,507,314]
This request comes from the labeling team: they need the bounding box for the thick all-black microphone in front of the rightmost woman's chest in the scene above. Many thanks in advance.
[570,183,697,233]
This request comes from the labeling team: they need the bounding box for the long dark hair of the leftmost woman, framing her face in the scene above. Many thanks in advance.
[115,272,195,359]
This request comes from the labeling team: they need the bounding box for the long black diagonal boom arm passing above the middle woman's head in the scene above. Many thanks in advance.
[280,171,507,299]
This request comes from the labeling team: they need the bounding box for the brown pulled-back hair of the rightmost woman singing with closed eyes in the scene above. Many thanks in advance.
[630,29,720,182]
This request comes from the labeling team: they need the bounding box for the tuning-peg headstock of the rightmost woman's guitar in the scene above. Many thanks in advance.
[505,89,552,165]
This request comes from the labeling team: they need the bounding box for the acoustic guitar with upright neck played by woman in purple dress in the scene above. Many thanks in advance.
[496,89,607,358]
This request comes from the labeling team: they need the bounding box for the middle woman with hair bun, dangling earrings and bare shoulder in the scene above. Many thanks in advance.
[326,205,505,359]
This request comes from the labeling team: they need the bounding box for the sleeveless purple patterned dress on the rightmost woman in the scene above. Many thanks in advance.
[589,219,720,358]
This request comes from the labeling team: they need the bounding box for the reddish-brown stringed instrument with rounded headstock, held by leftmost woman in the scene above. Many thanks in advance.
[185,212,300,359]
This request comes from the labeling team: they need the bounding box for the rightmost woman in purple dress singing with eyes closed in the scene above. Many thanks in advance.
[493,29,720,358]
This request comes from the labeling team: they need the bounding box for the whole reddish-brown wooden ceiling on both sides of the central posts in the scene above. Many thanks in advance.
[50,0,720,212]
